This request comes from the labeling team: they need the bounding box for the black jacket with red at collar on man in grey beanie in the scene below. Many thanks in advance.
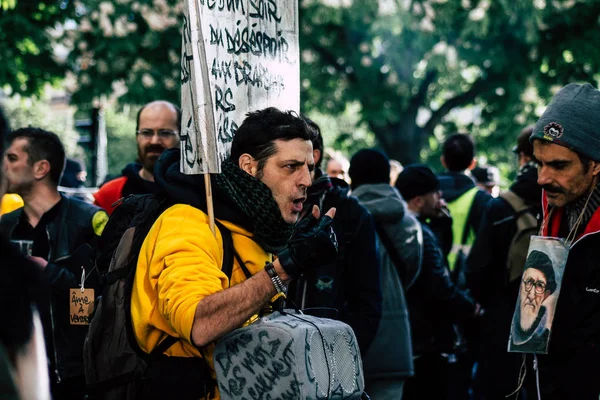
[538,193,600,400]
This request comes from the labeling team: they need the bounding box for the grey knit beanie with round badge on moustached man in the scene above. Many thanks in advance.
[529,83,600,161]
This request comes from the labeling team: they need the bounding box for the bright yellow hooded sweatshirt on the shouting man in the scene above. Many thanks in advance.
[131,204,272,398]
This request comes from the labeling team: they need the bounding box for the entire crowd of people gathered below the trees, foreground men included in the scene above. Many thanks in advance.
[0,84,600,400]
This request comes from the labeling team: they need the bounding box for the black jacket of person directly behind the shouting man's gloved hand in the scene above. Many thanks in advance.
[289,172,381,353]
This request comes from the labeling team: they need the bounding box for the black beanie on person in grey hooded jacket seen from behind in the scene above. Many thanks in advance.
[348,149,390,188]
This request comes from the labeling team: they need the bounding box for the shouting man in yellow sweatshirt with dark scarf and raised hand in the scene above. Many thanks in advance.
[131,108,337,399]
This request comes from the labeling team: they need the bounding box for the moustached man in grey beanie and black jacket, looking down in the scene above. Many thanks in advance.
[530,84,600,400]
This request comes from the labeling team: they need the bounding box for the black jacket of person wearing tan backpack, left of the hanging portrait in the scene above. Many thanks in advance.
[466,163,542,400]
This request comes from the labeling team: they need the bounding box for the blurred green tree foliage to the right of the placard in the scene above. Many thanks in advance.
[300,0,600,163]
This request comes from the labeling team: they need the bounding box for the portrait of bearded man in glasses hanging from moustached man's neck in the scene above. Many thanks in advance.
[508,236,569,354]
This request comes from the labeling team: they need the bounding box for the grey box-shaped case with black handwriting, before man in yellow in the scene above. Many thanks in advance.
[213,310,364,400]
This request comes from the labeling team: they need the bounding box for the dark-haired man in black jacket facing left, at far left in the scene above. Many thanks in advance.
[0,127,108,400]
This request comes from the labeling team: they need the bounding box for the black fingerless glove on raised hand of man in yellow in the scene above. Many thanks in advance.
[278,214,338,278]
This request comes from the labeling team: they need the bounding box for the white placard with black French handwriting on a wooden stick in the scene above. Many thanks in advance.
[181,0,300,174]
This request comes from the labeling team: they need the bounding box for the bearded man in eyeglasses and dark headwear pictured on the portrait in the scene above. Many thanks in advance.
[511,250,556,353]
